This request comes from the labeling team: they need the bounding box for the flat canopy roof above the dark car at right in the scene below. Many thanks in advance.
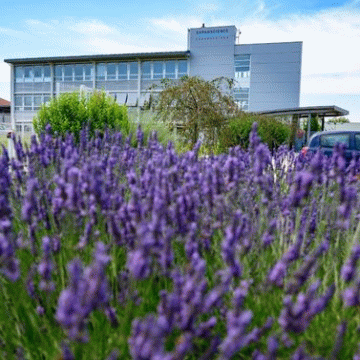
[257,105,349,117]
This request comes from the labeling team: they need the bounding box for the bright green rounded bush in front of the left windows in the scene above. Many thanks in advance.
[33,91,129,140]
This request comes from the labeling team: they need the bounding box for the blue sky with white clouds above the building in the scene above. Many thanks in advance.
[0,0,360,122]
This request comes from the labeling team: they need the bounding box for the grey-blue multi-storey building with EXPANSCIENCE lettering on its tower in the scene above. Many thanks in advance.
[5,26,302,131]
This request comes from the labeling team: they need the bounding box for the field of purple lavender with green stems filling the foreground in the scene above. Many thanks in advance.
[0,122,360,360]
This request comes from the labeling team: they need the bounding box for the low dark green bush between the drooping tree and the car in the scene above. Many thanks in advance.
[219,113,291,152]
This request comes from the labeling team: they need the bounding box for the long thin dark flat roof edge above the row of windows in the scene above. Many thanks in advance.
[4,50,190,65]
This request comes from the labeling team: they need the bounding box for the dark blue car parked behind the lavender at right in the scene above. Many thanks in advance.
[302,130,360,163]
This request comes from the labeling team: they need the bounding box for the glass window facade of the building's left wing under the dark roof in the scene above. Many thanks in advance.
[14,59,188,115]
